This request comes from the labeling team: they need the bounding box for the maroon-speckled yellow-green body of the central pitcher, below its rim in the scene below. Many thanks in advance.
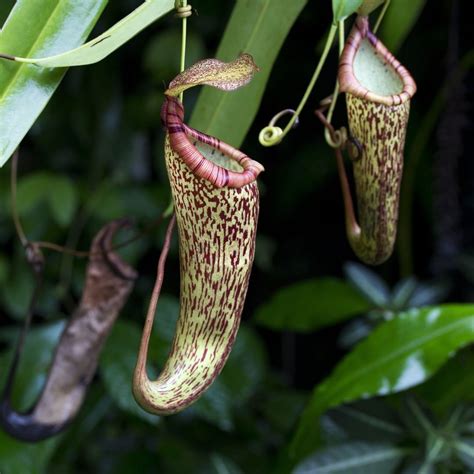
[134,135,259,414]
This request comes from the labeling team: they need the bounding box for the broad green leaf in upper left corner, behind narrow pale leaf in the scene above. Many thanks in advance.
[0,0,107,166]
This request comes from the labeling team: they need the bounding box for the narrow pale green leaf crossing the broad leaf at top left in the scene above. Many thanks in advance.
[0,0,175,67]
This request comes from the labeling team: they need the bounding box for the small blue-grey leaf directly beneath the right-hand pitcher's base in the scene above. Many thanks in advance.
[344,262,390,307]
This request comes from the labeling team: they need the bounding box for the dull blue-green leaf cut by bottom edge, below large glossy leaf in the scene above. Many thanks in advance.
[294,441,407,474]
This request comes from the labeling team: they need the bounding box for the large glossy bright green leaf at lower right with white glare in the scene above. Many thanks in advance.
[292,305,474,459]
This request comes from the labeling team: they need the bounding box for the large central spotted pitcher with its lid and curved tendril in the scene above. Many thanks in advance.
[133,54,263,415]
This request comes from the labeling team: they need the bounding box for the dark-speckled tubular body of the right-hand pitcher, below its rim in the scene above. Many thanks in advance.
[347,94,410,265]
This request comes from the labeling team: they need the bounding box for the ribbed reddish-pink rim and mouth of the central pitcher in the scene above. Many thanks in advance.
[161,96,264,188]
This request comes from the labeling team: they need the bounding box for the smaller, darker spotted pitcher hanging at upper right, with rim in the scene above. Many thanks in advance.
[338,15,416,265]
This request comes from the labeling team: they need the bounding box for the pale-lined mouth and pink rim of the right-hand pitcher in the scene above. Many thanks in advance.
[338,16,416,106]
